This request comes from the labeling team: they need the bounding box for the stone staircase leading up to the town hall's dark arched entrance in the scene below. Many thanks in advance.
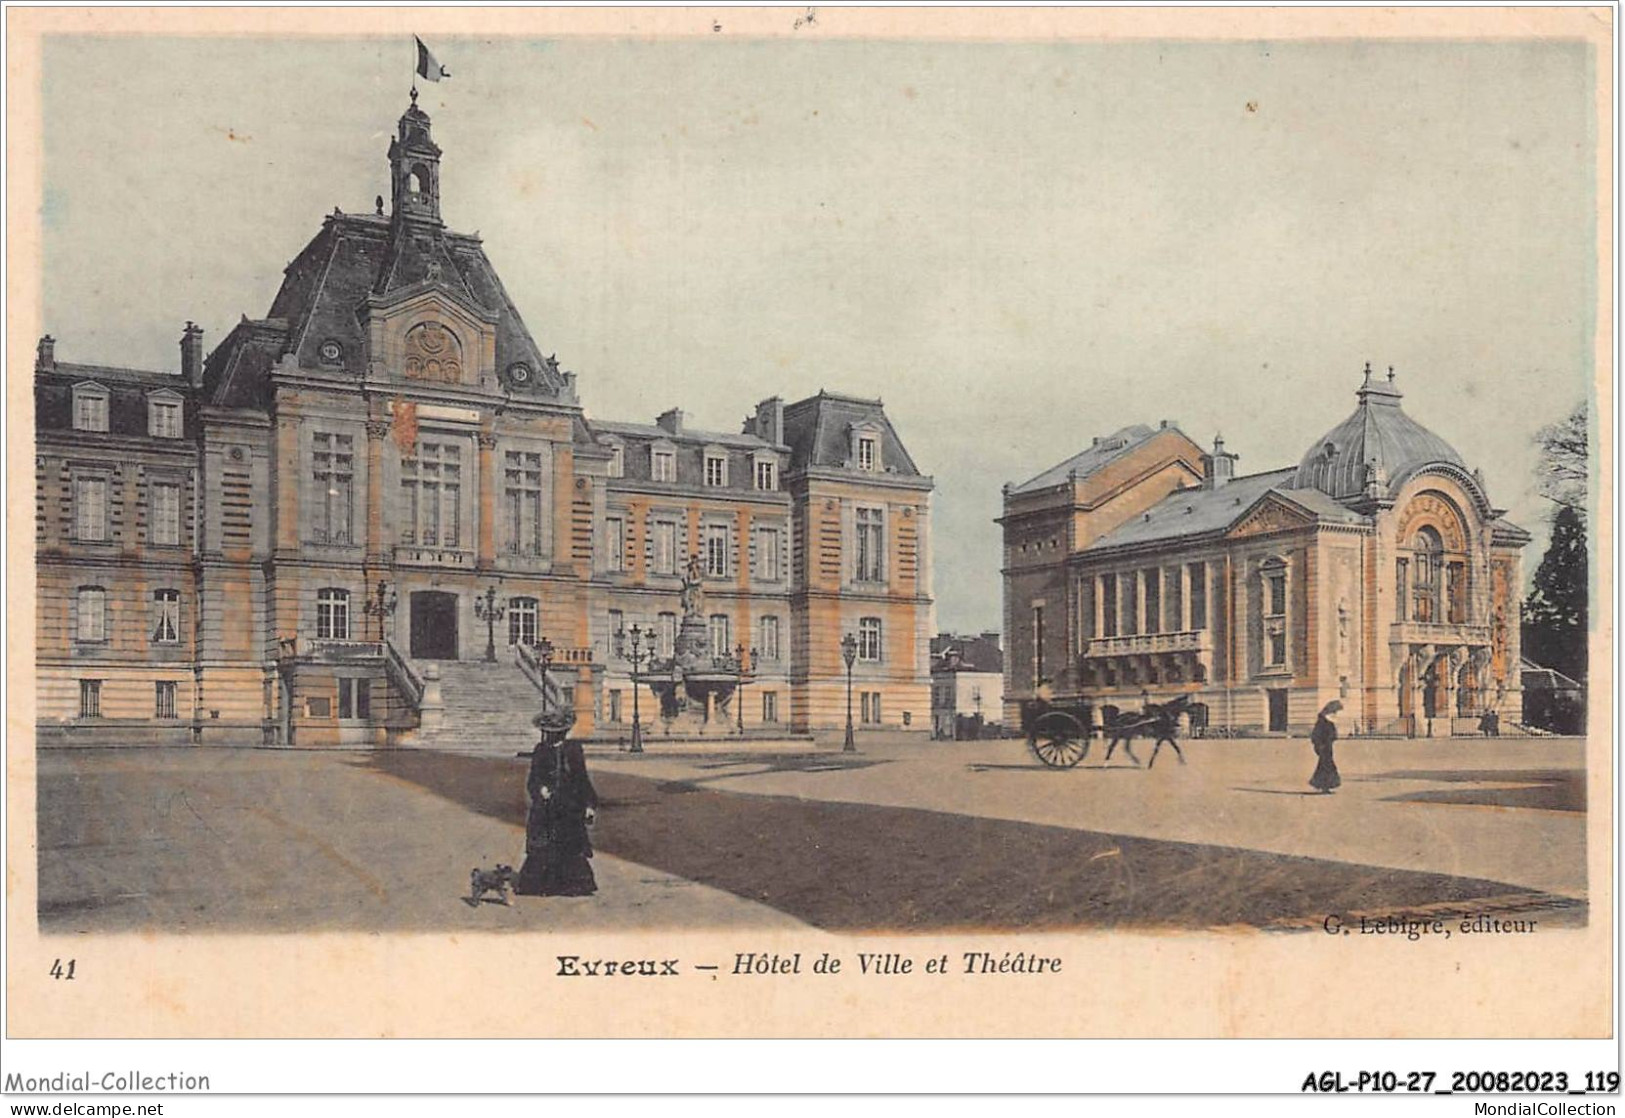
[401,658,541,756]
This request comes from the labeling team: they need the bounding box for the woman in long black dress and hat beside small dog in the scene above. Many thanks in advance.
[514,712,598,897]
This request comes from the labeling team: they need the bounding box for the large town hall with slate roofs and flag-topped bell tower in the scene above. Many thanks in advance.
[34,93,933,748]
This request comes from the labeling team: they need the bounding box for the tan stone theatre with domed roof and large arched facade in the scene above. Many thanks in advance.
[999,367,1529,735]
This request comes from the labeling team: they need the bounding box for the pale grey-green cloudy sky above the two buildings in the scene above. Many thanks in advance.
[39,36,1596,632]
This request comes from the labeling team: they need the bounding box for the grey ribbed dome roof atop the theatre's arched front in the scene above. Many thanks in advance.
[1292,366,1466,499]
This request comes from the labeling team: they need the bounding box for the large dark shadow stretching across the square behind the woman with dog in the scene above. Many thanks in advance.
[368,751,1583,931]
